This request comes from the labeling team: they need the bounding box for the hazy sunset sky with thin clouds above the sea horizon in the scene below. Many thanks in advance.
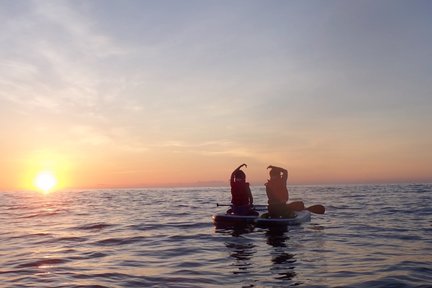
[0,0,432,190]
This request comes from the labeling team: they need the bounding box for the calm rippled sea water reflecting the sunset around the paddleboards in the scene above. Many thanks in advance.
[0,184,432,287]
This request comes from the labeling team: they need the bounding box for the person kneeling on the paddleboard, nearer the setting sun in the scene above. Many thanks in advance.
[228,164,258,215]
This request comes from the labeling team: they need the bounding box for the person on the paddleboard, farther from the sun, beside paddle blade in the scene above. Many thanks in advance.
[265,165,305,218]
